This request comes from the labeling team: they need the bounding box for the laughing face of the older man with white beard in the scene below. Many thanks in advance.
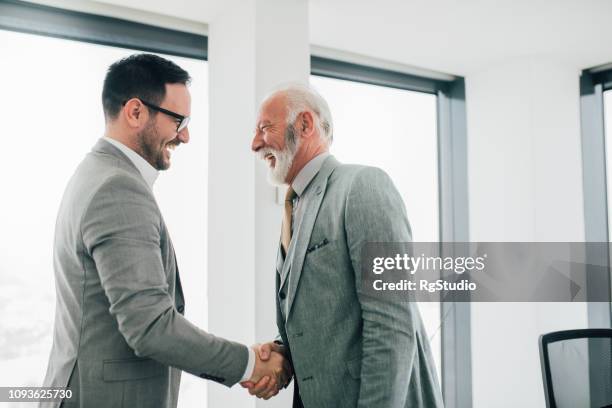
[251,94,299,185]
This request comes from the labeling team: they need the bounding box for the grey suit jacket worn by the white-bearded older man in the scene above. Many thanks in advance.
[276,156,443,408]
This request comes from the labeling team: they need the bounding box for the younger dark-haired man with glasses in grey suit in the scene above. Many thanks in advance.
[43,54,285,408]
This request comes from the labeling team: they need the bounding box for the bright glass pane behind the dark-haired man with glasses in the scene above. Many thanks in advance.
[0,30,208,407]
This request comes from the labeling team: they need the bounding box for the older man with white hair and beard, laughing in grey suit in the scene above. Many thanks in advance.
[244,86,442,408]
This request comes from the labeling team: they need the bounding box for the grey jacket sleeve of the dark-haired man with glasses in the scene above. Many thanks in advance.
[81,176,248,386]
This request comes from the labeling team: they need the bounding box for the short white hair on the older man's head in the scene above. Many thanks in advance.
[265,83,334,145]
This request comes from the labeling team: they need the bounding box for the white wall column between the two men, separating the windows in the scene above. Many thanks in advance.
[208,0,310,408]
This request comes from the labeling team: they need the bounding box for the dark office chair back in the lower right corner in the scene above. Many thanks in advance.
[540,329,612,408]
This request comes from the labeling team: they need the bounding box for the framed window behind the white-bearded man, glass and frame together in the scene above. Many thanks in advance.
[311,55,472,408]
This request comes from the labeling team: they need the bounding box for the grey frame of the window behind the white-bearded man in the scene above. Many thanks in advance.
[310,55,472,408]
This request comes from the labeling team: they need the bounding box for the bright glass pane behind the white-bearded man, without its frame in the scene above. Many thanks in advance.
[310,76,441,378]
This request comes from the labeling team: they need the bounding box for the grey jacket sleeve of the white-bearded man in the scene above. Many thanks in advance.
[345,167,419,408]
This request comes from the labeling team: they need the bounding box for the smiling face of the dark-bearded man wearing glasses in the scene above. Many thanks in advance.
[137,84,191,170]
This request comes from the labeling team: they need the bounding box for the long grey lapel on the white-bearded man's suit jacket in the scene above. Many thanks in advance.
[280,156,339,320]
